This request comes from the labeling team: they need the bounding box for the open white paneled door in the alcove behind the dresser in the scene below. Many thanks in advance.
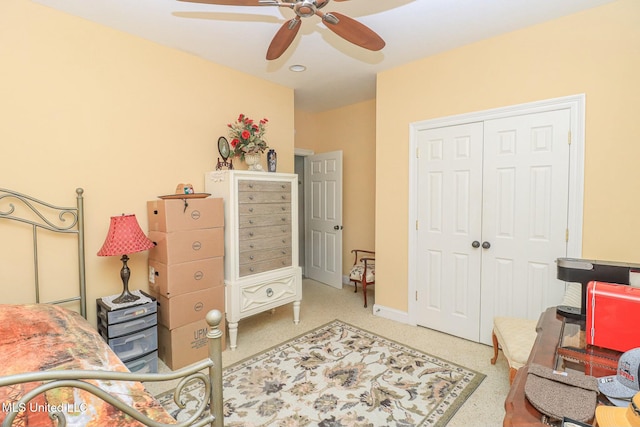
[304,151,342,288]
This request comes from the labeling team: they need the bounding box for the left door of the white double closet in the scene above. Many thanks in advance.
[417,122,483,340]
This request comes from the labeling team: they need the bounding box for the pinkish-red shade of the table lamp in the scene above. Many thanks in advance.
[98,215,154,256]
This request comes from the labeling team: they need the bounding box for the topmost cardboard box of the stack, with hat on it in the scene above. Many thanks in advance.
[147,197,224,232]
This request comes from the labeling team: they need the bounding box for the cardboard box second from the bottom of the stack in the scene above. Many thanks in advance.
[152,286,224,329]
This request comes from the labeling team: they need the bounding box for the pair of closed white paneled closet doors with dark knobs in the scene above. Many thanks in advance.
[416,110,570,344]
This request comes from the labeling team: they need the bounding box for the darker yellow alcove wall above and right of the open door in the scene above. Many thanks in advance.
[295,100,376,274]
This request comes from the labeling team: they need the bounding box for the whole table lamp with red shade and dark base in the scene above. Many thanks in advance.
[98,214,154,304]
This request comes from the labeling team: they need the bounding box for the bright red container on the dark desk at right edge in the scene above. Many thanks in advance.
[585,281,640,352]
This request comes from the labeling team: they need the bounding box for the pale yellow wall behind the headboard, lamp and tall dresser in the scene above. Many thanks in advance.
[0,0,294,321]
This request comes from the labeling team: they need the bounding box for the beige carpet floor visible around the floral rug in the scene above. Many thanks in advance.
[147,279,509,427]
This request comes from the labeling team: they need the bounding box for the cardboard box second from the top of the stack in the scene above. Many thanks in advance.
[149,227,224,265]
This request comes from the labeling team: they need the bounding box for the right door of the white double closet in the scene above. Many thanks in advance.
[480,109,571,344]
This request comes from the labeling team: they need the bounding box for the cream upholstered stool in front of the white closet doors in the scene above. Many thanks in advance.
[491,317,538,384]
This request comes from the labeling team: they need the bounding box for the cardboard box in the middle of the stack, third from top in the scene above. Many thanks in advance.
[149,257,224,298]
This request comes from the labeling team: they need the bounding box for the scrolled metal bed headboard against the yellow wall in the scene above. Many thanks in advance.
[0,188,87,319]
